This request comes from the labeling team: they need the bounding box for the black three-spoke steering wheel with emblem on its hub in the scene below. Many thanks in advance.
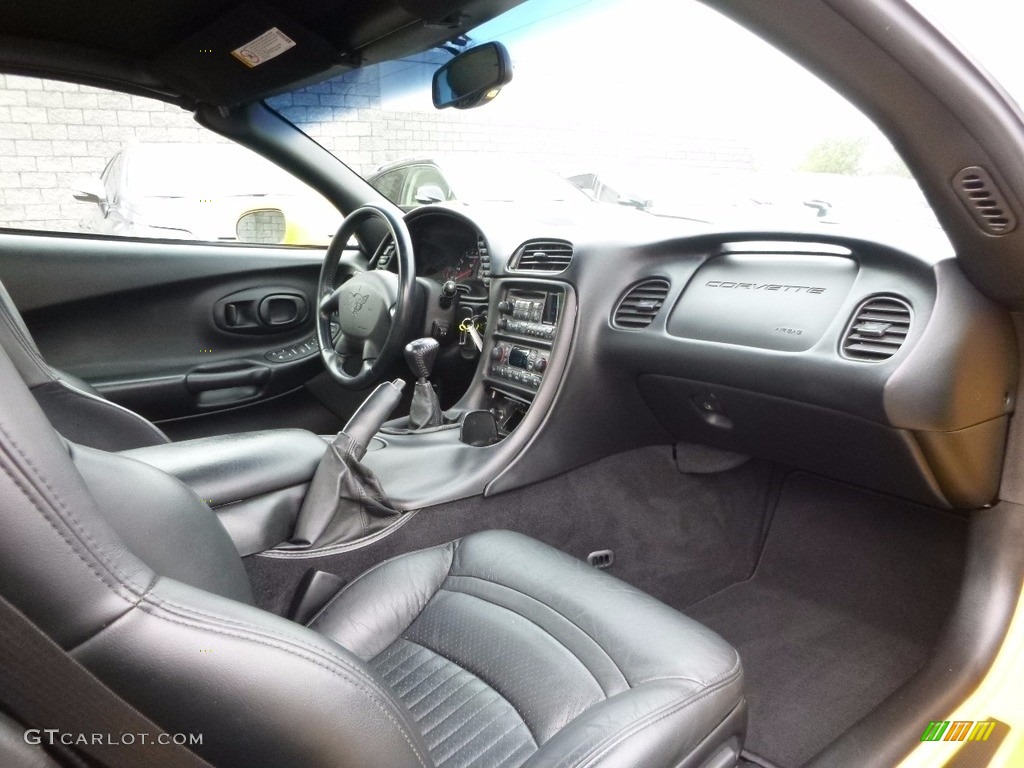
[316,204,416,389]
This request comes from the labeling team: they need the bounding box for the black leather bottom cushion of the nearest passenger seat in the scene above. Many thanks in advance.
[309,530,745,768]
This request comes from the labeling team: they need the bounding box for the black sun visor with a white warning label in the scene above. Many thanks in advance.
[154,3,338,106]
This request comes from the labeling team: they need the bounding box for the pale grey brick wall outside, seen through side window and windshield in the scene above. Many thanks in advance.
[0,65,752,231]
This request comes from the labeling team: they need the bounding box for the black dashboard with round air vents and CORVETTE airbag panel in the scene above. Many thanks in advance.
[391,206,1017,508]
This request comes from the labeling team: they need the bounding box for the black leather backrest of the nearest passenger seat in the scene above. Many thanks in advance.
[0,342,431,768]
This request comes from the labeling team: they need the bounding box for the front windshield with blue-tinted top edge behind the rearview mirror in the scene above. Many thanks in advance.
[268,0,938,230]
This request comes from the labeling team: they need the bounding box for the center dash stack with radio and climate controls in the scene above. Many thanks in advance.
[484,286,565,436]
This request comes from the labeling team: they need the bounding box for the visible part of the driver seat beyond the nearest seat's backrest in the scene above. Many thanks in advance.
[0,283,171,451]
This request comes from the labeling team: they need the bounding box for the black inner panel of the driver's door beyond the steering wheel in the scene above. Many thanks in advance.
[0,234,357,436]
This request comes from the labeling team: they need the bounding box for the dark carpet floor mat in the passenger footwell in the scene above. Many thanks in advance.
[685,473,967,768]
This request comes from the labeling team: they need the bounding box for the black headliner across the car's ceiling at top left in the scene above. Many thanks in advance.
[0,0,520,106]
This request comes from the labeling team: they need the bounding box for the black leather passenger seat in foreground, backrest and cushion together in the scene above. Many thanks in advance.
[0,342,745,768]
